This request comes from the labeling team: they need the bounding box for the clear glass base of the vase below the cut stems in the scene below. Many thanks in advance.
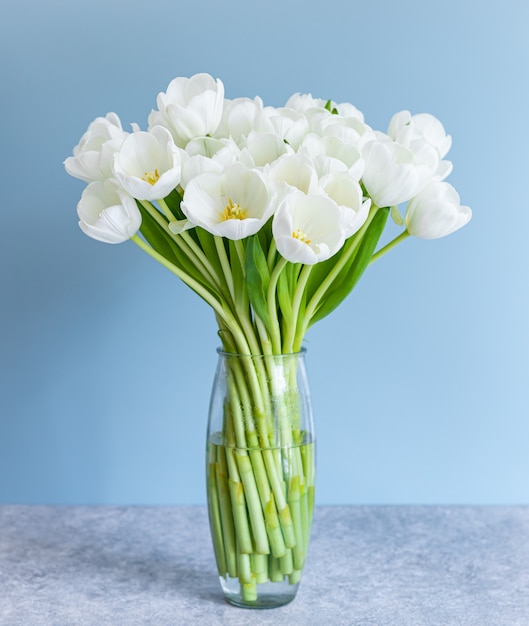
[220,576,299,609]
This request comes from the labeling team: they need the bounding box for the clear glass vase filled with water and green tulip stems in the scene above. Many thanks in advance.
[206,350,315,608]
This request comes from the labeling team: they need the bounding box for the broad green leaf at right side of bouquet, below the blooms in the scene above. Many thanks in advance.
[310,208,389,326]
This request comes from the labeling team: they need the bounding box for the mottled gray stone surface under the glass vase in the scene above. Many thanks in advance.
[0,506,529,626]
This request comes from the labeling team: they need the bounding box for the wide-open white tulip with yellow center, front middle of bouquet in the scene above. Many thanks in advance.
[181,163,274,239]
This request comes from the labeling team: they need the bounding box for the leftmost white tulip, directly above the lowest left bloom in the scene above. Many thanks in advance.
[64,113,129,183]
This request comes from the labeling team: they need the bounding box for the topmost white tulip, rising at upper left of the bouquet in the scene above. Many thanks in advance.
[149,74,224,147]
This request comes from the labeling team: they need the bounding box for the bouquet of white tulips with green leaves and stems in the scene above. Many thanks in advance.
[65,74,471,601]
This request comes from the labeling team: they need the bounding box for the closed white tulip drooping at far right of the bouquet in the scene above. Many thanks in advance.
[406,181,472,239]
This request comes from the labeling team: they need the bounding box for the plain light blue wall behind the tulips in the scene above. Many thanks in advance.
[0,0,529,504]
